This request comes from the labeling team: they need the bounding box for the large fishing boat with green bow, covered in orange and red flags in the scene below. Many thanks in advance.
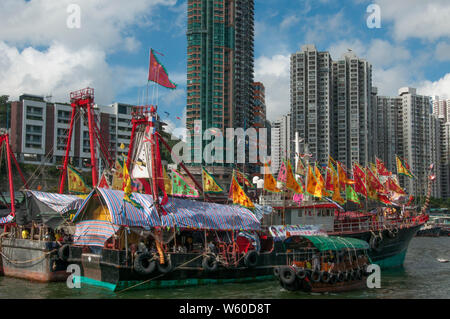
[259,151,433,269]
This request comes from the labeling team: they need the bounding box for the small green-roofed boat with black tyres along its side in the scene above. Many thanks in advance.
[275,236,371,293]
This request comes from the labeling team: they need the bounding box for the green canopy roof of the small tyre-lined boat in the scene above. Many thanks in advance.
[288,236,369,251]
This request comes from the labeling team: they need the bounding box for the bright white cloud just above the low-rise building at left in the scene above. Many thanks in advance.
[0,42,114,102]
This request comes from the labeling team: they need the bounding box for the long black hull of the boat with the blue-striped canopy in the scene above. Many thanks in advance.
[69,246,286,291]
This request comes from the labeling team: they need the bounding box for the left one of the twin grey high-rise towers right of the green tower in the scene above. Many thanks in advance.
[290,45,333,165]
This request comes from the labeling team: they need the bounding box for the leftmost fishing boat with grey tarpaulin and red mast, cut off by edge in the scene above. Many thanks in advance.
[0,134,83,282]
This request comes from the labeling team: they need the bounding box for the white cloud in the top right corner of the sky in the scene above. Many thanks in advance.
[375,0,450,41]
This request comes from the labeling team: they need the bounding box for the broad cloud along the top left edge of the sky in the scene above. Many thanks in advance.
[0,0,176,51]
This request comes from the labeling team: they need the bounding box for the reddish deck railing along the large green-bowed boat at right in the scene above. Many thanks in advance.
[332,217,422,234]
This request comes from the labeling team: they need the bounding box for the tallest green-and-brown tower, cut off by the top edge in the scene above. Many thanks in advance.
[186,0,254,165]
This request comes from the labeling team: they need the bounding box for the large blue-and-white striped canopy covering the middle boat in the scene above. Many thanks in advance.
[73,188,260,230]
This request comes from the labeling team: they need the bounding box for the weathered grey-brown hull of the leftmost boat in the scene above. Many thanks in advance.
[1,238,69,282]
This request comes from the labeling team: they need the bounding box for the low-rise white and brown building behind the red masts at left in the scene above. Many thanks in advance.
[10,94,133,170]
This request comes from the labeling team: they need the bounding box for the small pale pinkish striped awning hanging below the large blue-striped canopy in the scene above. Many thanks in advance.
[73,220,120,247]
